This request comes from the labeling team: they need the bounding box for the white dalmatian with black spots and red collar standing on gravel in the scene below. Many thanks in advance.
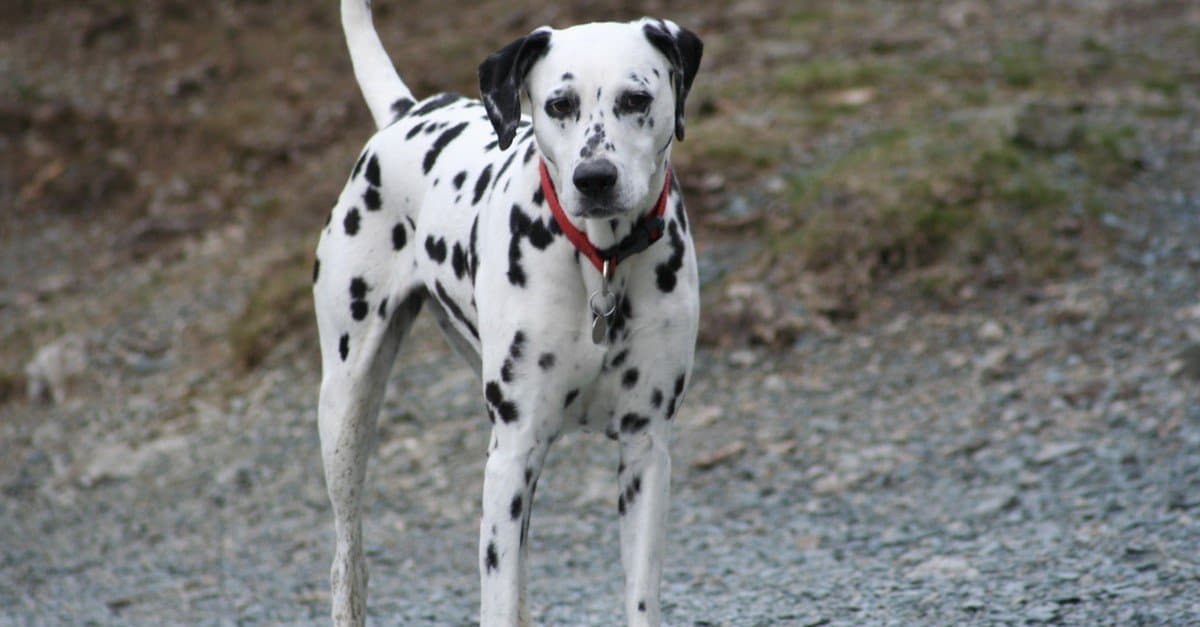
[313,0,702,626]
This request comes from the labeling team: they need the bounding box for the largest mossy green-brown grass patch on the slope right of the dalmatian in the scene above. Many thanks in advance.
[767,107,1135,307]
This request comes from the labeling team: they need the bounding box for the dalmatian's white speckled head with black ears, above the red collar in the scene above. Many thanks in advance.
[479,18,703,217]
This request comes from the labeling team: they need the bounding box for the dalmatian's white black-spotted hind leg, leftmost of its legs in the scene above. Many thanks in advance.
[313,145,426,625]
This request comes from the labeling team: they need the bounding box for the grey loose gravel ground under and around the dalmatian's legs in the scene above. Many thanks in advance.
[0,176,1200,626]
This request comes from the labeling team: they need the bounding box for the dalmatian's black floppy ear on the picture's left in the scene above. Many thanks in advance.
[479,29,550,150]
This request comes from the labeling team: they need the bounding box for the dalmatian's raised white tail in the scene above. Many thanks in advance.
[342,0,414,129]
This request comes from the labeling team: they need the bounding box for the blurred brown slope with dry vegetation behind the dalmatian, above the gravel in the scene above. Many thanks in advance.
[0,0,1200,374]
